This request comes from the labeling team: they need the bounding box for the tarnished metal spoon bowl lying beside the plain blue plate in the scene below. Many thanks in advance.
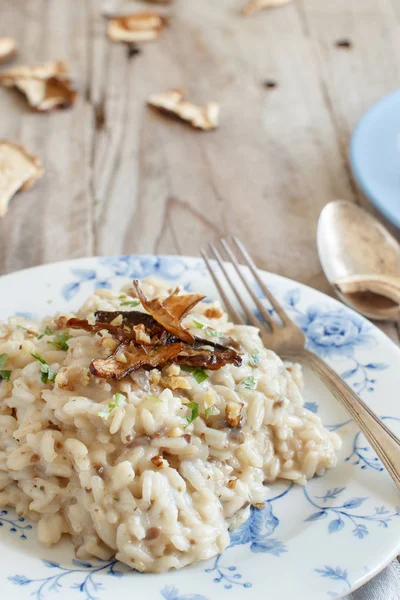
[317,200,400,321]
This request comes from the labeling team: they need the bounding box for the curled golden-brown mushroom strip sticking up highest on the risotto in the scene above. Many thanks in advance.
[133,279,201,344]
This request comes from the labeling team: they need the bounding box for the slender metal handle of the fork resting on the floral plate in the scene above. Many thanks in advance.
[299,350,400,490]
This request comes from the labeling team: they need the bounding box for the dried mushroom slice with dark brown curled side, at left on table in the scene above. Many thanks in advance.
[0,60,77,112]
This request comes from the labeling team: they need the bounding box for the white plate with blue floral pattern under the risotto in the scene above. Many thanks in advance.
[0,256,400,600]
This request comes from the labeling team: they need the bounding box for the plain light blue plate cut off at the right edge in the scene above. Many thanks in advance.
[350,90,400,228]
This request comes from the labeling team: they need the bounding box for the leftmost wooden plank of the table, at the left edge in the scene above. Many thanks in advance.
[0,0,93,272]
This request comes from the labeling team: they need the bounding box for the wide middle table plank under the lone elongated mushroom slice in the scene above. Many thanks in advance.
[94,0,352,296]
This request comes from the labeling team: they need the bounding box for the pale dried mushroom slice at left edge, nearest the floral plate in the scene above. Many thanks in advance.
[0,141,44,217]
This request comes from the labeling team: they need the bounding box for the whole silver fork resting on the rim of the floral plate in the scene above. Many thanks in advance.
[201,237,400,490]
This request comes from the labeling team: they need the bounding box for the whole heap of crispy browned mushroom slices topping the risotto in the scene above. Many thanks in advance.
[63,280,242,380]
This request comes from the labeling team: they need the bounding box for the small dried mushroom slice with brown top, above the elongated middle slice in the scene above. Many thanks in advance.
[108,11,167,44]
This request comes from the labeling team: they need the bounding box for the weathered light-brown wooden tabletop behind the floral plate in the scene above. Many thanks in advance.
[0,0,400,337]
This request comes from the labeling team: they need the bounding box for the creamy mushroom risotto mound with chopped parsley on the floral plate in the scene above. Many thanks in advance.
[0,280,340,572]
